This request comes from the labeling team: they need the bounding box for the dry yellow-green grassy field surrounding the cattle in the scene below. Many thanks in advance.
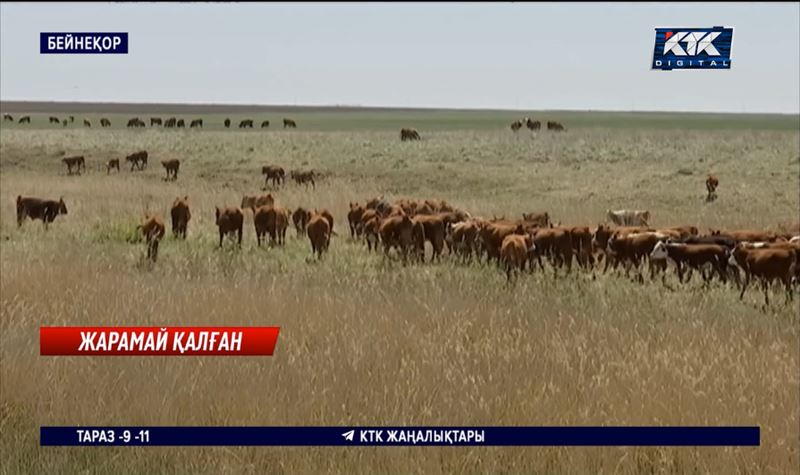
[0,105,800,474]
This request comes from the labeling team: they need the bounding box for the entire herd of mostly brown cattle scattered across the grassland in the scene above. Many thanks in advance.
[5,114,800,305]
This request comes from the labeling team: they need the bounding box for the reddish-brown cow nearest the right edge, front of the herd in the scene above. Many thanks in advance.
[728,243,798,305]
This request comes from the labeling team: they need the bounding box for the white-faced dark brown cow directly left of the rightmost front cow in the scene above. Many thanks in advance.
[650,240,728,283]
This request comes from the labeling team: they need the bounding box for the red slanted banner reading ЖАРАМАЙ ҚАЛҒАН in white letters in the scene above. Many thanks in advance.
[39,327,280,356]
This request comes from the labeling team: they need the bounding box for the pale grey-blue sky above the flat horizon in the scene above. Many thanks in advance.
[0,2,800,114]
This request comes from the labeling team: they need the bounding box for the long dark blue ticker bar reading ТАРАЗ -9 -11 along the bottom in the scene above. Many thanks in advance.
[40,426,761,447]
